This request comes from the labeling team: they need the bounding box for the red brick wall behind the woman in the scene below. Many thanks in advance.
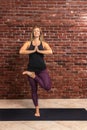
[0,0,87,98]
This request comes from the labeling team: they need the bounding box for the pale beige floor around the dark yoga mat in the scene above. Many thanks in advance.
[0,99,87,130]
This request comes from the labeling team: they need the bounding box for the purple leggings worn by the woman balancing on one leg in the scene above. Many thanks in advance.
[28,69,51,106]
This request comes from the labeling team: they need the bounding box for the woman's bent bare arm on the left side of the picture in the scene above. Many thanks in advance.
[19,41,36,54]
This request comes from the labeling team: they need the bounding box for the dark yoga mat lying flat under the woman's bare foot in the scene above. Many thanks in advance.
[0,108,87,121]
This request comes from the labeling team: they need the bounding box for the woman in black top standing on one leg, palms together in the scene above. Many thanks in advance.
[19,26,52,117]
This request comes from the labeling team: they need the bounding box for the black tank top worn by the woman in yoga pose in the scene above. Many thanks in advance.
[28,42,46,72]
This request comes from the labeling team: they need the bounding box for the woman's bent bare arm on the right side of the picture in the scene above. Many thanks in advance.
[37,42,52,54]
